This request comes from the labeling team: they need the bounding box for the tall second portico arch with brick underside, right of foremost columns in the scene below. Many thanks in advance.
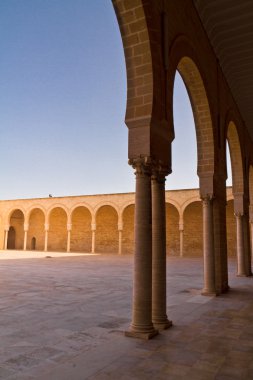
[167,35,216,187]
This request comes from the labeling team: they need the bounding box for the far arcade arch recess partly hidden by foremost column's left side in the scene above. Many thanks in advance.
[122,205,134,253]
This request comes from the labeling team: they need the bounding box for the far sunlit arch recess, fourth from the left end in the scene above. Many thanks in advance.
[70,206,91,252]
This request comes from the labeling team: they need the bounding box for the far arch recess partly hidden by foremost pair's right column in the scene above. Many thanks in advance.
[166,203,180,256]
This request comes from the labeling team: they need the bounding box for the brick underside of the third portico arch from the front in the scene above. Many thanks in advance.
[227,121,244,195]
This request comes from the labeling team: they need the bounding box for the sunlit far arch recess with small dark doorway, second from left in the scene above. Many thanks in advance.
[27,208,45,251]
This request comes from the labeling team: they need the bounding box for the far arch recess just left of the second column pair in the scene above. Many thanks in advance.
[183,200,203,257]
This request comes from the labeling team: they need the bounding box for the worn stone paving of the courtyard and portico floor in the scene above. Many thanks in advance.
[0,252,253,380]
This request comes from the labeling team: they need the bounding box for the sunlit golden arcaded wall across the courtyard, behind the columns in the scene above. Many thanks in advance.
[0,188,236,257]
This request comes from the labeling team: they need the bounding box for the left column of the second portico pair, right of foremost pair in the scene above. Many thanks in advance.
[202,195,216,296]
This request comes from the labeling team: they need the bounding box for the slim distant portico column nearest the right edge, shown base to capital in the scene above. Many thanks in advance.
[235,212,247,277]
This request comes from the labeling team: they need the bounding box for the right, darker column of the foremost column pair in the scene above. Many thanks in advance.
[152,169,172,330]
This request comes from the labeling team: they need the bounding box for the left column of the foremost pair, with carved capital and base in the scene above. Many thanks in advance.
[125,158,158,339]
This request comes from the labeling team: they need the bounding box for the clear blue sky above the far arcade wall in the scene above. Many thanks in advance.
[0,0,230,199]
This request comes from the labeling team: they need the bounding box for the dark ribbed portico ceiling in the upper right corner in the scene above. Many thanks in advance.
[193,0,253,141]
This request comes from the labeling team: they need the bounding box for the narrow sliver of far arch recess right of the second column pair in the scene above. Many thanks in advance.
[226,199,236,257]
